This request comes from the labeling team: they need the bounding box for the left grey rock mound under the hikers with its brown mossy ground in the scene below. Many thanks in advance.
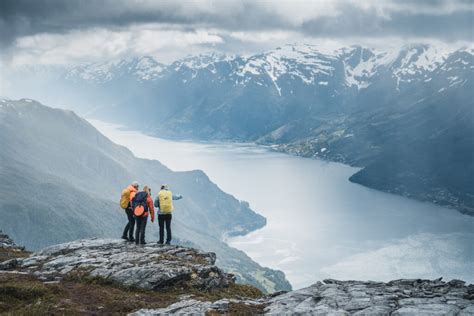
[0,234,262,315]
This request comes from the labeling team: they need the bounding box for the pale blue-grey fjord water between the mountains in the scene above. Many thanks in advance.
[91,120,474,288]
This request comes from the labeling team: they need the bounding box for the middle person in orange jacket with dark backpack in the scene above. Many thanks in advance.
[130,185,155,245]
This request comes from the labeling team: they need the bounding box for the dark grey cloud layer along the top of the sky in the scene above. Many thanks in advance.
[0,0,473,46]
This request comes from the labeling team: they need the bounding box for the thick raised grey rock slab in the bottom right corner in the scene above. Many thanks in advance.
[265,279,473,315]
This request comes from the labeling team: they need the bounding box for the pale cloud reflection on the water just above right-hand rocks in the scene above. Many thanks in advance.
[321,233,474,282]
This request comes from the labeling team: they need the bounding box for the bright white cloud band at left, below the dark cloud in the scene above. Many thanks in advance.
[10,24,223,66]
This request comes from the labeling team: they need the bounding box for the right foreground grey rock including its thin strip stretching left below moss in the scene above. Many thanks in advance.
[133,279,474,316]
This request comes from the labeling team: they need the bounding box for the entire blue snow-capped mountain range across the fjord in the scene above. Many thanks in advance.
[2,44,474,214]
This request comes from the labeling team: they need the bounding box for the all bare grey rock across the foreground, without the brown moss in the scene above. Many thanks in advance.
[0,235,474,316]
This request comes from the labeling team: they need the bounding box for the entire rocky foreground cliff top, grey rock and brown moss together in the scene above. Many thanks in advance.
[0,234,474,315]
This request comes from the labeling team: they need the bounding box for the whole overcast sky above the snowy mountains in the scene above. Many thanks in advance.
[0,0,474,65]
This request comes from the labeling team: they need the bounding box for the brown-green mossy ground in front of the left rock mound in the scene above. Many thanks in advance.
[0,273,262,315]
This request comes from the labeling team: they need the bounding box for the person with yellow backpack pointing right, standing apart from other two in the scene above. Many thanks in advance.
[155,184,183,245]
